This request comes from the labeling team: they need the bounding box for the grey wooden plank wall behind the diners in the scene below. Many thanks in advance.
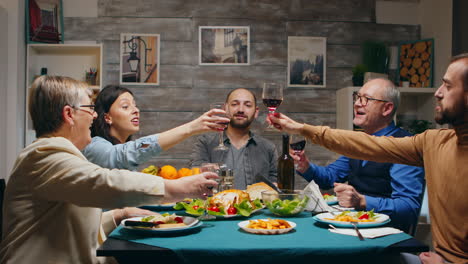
[64,0,420,188]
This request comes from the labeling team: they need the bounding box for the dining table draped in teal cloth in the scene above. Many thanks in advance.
[96,209,429,264]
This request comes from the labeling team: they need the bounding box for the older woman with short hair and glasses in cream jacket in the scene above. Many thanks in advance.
[0,76,217,263]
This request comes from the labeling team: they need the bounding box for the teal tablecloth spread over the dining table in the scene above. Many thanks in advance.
[110,211,411,263]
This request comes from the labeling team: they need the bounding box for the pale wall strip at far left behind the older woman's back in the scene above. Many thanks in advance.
[0,0,26,182]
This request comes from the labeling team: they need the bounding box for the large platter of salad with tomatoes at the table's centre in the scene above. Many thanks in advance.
[174,198,264,219]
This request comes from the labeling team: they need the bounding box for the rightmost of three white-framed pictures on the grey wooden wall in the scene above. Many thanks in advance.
[288,37,327,87]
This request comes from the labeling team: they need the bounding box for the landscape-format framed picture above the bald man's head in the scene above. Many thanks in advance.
[198,26,250,65]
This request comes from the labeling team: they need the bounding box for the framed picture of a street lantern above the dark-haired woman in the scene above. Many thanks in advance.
[120,33,160,85]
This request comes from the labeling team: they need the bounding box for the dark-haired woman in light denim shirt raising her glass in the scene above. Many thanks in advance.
[83,85,229,170]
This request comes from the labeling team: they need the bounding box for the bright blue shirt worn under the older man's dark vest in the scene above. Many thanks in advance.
[299,122,425,232]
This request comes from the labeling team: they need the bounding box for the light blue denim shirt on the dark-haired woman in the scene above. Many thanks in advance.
[82,134,162,170]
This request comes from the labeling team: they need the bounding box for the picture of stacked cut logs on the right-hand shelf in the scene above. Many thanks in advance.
[398,39,434,87]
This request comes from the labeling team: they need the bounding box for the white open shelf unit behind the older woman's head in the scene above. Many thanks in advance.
[25,44,102,146]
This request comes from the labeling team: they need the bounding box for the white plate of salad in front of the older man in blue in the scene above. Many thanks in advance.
[313,210,390,228]
